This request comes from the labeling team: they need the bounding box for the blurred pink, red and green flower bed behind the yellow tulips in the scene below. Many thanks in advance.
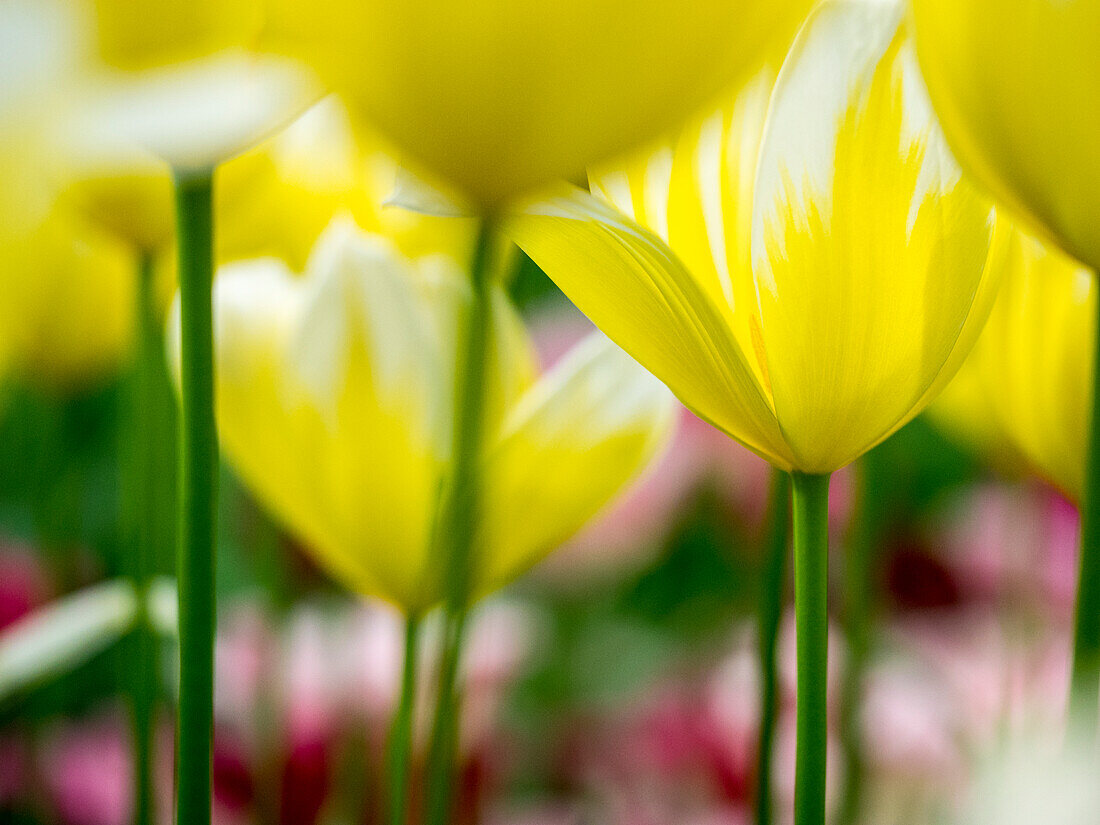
[0,251,1077,825]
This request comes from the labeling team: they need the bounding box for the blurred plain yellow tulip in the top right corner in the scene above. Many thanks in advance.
[913,0,1100,268]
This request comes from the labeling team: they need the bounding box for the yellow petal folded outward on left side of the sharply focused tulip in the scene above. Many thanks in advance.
[505,189,791,468]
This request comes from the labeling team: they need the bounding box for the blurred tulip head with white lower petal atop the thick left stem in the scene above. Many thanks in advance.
[72,0,319,174]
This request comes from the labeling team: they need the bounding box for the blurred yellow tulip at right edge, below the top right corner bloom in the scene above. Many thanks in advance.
[964,223,1097,501]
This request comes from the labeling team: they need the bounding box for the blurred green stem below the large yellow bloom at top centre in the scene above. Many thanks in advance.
[427,219,494,825]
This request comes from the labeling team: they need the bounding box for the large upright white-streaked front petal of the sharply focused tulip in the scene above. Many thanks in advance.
[752,0,992,473]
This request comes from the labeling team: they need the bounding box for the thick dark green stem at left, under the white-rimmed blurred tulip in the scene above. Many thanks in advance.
[176,173,218,825]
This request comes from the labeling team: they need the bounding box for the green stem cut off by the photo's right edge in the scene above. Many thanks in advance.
[1069,286,1100,736]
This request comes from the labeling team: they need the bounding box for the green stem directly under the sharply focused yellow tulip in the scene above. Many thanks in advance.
[791,473,829,825]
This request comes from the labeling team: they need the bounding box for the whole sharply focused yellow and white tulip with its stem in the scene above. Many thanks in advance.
[507,0,996,825]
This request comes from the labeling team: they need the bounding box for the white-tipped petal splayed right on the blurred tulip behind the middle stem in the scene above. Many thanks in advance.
[476,333,677,592]
